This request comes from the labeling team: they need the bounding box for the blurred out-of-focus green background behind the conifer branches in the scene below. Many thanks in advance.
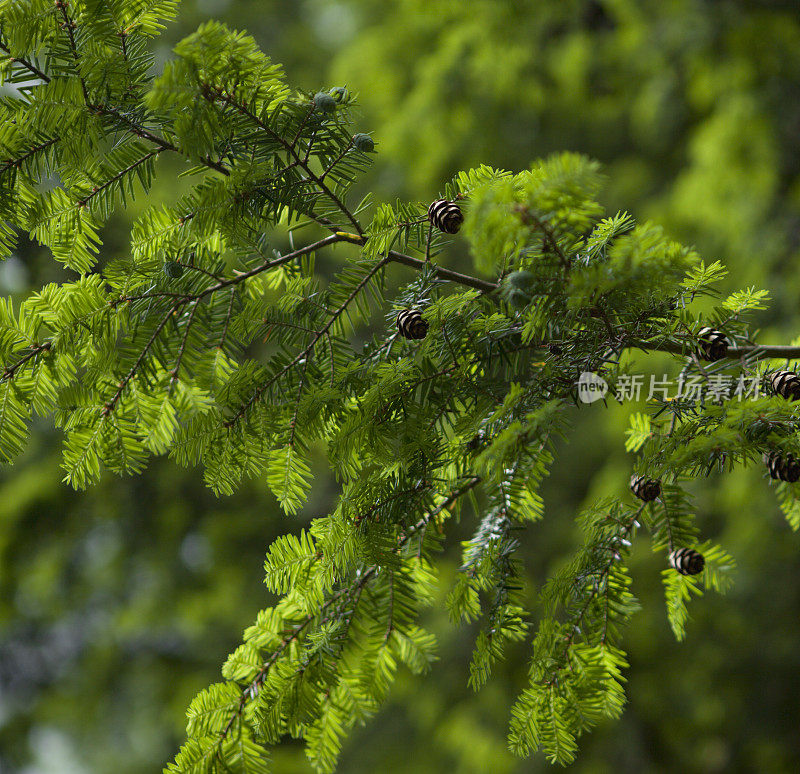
[0,0,800,774]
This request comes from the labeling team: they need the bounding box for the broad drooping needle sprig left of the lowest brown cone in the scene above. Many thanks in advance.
[509,503,641,764]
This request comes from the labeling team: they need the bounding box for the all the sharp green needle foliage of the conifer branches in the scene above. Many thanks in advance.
[0,2,800,773]
